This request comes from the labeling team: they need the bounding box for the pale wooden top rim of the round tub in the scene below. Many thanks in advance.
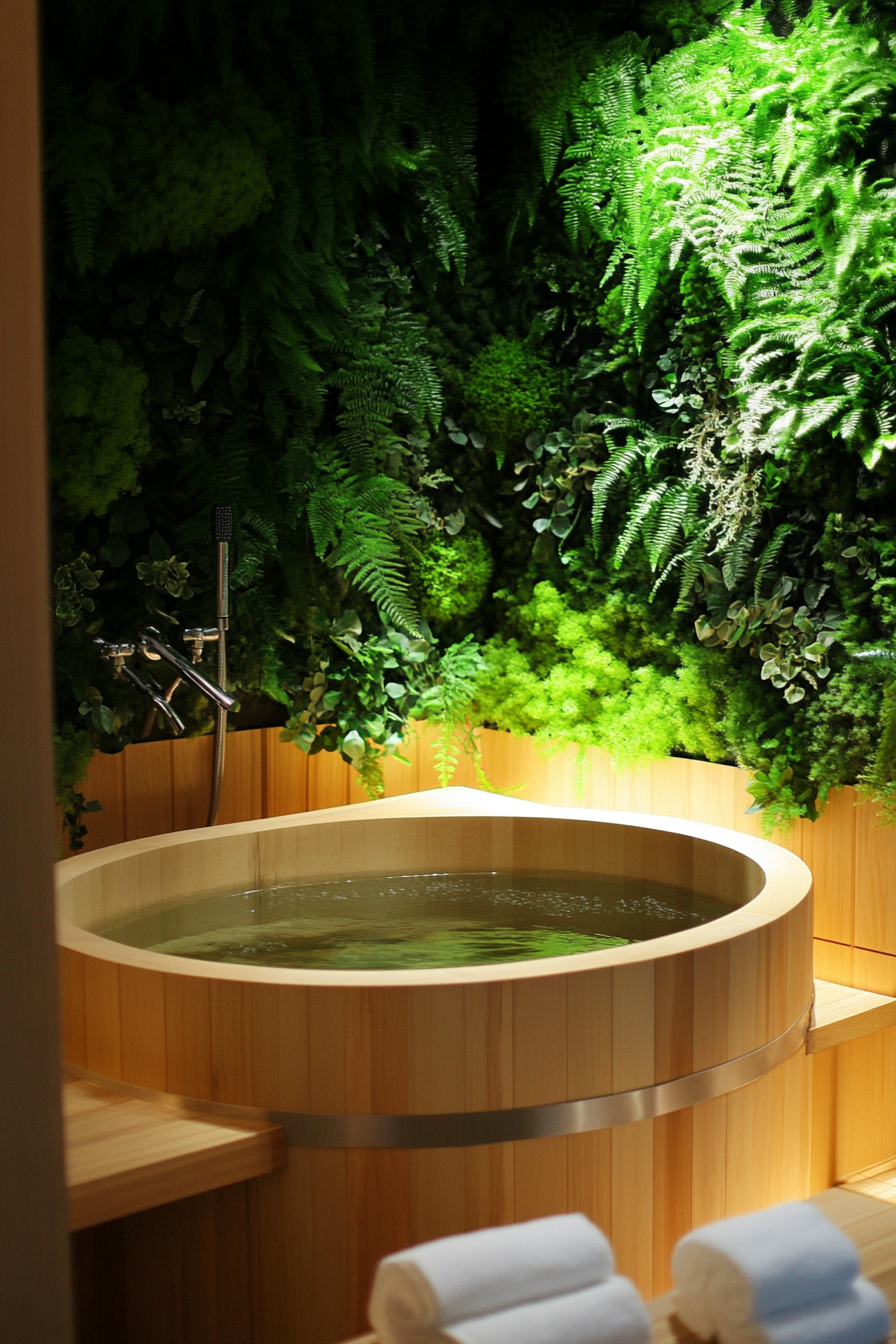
[56,788,813,989]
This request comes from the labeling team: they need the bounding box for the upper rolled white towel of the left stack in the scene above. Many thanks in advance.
[368,1214,615,1344]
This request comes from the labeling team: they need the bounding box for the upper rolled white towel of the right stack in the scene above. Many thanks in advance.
[672,1203,858,1339]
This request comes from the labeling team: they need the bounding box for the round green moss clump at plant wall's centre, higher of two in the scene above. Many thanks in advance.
[463,336,563,464]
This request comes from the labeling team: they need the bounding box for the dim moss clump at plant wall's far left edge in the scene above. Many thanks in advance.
[50,327,150,519]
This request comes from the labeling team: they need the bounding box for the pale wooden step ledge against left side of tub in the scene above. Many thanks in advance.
[63,1081,286,1232]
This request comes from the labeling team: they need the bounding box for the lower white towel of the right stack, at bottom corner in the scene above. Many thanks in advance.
[719,1278,889,1344]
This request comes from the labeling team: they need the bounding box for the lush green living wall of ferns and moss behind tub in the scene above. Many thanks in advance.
[44,0,896,844]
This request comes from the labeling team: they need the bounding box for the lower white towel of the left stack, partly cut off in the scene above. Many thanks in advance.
[445,1275,652,1344]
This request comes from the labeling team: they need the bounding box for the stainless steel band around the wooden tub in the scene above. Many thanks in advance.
[69,1001,811,1148]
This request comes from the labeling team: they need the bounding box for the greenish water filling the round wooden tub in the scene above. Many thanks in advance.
[95,872,731,970]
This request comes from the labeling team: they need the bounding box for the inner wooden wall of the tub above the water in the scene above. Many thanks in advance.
[60,817,764,929]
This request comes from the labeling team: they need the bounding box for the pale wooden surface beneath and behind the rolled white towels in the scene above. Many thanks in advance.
[338,1189,896,1344]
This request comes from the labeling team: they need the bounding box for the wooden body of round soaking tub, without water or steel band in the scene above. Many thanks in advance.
[59,793,811,1344]
